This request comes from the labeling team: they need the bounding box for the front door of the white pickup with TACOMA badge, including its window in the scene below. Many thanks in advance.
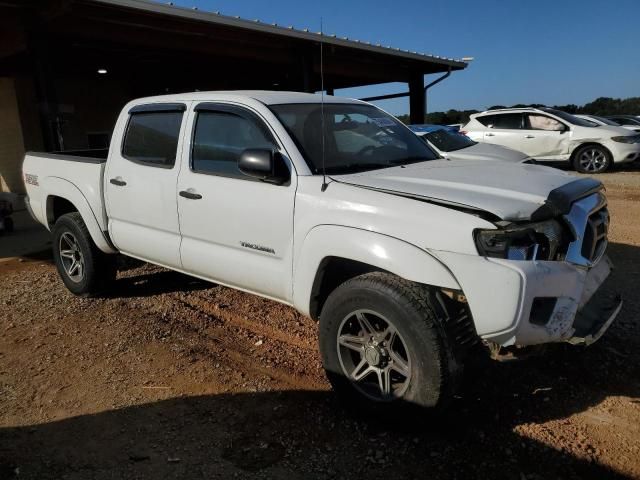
[178,103,296,301]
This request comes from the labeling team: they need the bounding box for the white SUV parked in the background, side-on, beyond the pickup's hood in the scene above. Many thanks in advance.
[462,108,640,173]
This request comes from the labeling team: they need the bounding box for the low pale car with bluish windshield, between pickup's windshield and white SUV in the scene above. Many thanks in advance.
[409,125,530,163]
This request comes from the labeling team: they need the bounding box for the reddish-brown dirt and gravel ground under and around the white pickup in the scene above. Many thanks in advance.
[0,170,640,480]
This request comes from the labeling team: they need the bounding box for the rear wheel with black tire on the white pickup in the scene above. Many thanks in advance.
[52,212,116,296]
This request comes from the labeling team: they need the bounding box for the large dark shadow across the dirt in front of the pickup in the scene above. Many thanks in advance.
[0,244,640,480]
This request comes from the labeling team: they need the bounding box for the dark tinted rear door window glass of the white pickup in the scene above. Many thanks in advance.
[122,111,183,168]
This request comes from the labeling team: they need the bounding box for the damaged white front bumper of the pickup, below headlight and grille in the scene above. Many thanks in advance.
[435,251,621,347]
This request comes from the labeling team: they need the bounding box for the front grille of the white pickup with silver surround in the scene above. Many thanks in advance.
[565,193,609,267]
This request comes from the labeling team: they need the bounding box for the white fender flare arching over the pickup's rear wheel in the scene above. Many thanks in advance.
[41,177,118,253]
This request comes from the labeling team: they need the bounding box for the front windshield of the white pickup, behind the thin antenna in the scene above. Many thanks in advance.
[270,103,438,174]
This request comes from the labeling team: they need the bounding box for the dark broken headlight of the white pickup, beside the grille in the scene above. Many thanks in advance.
[474,220,569,260]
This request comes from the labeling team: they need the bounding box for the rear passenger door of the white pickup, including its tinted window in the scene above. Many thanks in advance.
[104,103,186,268]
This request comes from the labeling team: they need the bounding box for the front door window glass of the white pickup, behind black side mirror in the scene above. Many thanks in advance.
[191,110,276,180]
